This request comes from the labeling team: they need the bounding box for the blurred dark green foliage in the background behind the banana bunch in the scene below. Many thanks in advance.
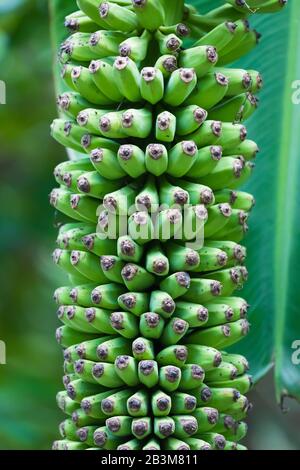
[0,0,300,450]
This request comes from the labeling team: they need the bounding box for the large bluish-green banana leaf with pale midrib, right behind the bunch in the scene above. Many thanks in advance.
[50,0,300,401]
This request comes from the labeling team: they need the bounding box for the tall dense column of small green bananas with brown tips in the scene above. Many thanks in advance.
[50,0,286,450]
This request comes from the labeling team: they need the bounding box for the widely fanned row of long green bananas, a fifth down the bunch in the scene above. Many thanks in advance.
[58,57,262,109]
